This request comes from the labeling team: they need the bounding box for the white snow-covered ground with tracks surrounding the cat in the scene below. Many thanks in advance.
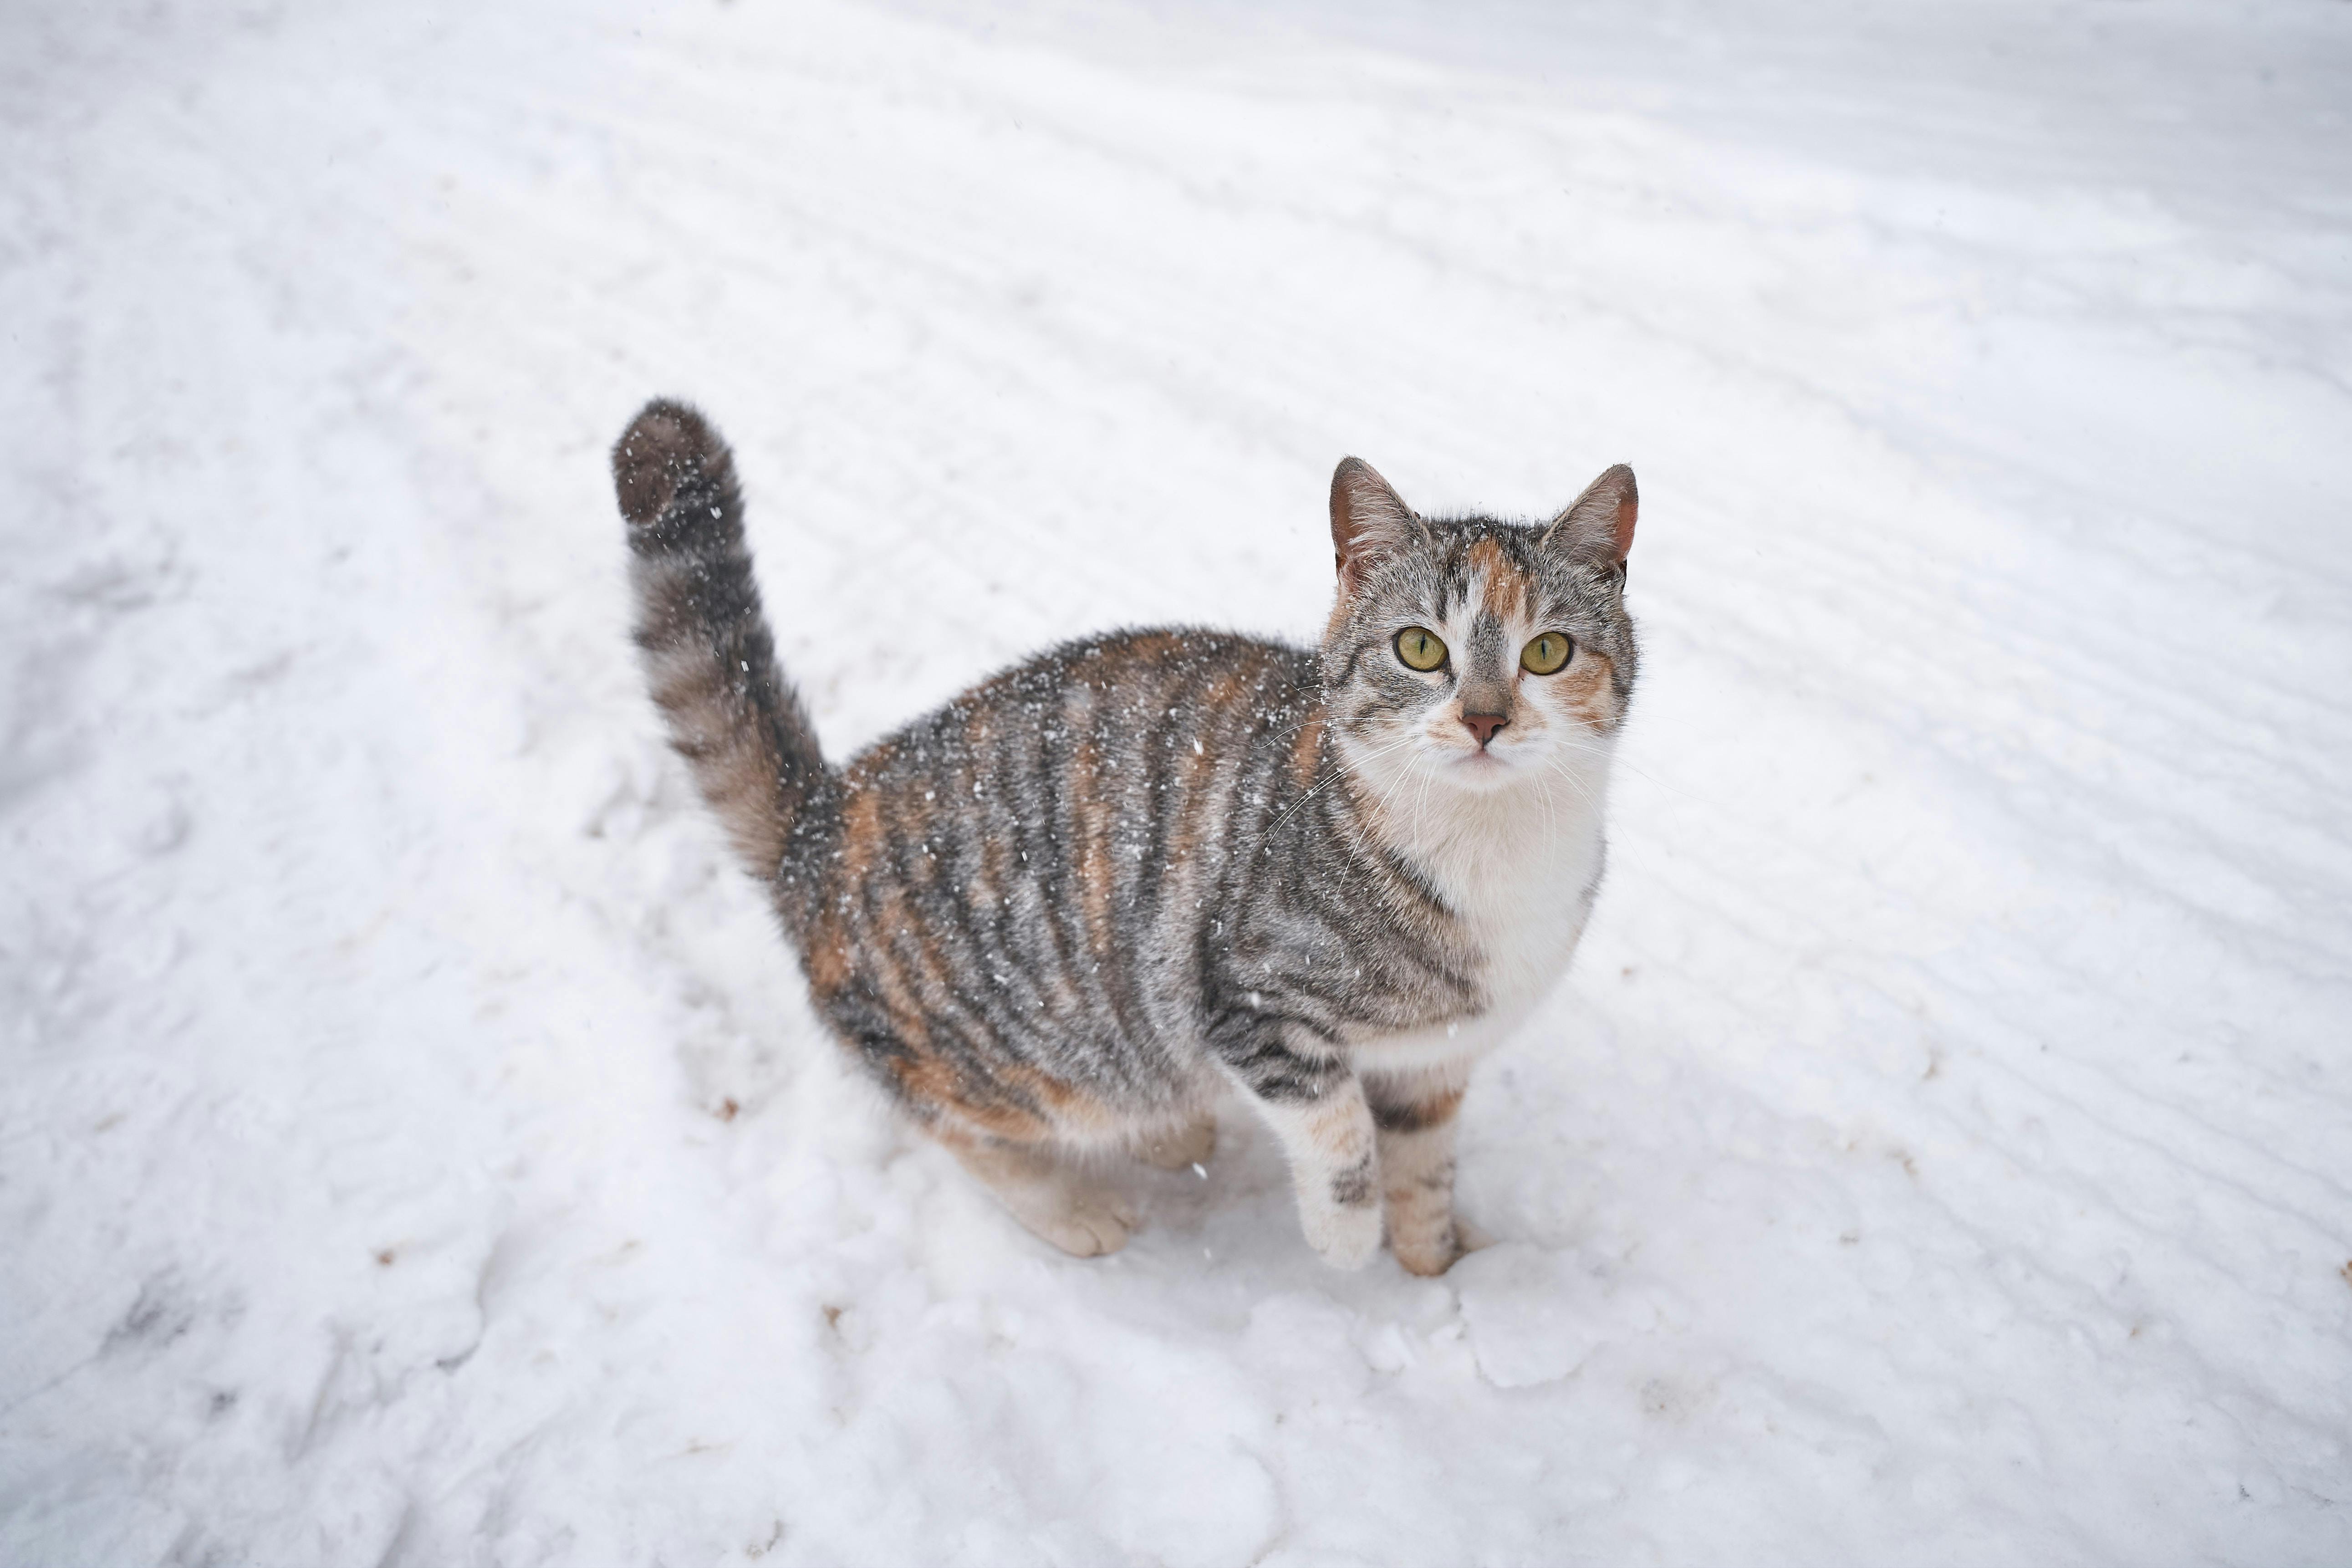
[0,0,2352,1568]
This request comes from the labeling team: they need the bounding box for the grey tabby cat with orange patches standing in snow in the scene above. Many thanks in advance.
[612,400,1637,1274]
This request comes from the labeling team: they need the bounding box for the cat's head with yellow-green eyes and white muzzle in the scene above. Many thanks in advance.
[1322,459,1637,792]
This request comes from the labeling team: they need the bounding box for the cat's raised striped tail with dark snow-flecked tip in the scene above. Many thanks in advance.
[612,397,830,917]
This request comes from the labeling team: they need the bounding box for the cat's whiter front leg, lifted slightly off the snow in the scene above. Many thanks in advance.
[1225,1030,1381,1269]
